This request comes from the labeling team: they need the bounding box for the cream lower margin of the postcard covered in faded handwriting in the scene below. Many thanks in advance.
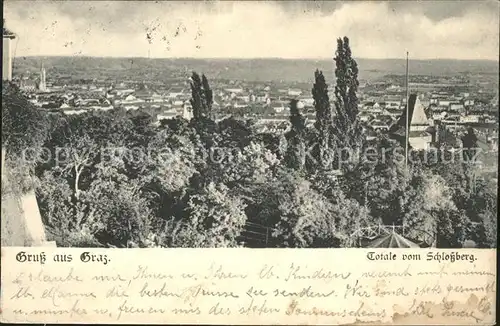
[2,248,496,325]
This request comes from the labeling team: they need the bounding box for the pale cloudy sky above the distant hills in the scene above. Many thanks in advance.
[4,0,499,60]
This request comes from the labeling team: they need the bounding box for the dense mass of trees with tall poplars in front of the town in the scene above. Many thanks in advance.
[2,38,497,247]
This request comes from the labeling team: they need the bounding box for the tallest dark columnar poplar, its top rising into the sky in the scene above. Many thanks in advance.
[333,37,363,162]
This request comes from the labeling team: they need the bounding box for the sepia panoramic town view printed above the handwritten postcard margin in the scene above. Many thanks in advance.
[1,0,499,249]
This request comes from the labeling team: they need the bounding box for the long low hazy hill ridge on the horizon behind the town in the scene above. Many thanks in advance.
[10,56,499,82]
